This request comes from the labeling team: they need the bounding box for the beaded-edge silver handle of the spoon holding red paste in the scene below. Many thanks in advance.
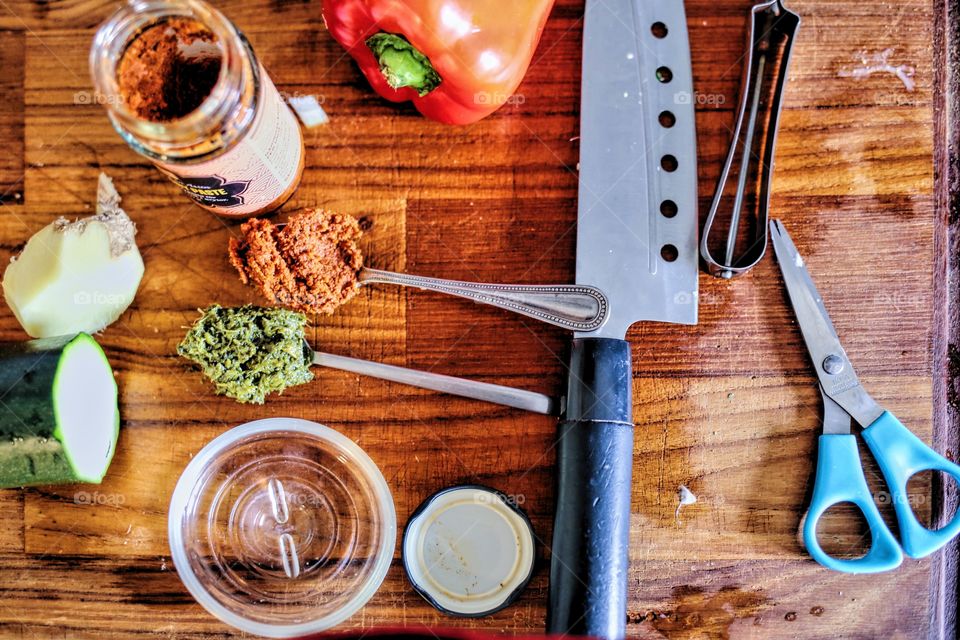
[360,267,608,332]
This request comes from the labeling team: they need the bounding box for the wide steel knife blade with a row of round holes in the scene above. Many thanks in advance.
[577,0,698,339]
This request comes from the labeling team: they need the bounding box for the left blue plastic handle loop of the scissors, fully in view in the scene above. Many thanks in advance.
[803,434,903,573]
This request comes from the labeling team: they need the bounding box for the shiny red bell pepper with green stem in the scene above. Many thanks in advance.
[323,0,554,124]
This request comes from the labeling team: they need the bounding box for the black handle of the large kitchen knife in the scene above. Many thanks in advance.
[547,338,633,639]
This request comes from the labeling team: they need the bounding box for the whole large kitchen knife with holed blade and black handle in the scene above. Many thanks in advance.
[547,0,698,638]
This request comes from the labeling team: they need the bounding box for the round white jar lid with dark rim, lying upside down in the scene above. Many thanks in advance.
[403,485,536,617]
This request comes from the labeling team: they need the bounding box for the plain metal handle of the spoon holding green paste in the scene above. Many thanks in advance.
[303,340,562,416]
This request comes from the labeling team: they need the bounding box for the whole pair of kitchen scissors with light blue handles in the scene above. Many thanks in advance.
[770,220,960,573]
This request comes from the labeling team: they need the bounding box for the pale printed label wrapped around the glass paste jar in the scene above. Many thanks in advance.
[156,67,303,217]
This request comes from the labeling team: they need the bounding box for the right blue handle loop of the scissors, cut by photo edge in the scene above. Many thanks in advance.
[863,411,960,558]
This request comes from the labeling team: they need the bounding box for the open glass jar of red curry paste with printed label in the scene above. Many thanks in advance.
[90,0,305,217]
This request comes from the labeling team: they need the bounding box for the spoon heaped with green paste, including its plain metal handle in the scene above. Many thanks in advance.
[177,305,561,415]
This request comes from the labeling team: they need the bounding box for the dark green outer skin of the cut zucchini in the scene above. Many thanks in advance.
[0,334,94,488]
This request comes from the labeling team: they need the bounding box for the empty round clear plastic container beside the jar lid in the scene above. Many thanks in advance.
[168,418,397,638]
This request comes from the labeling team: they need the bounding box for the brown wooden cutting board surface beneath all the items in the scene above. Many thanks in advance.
[0,0,955,640]
